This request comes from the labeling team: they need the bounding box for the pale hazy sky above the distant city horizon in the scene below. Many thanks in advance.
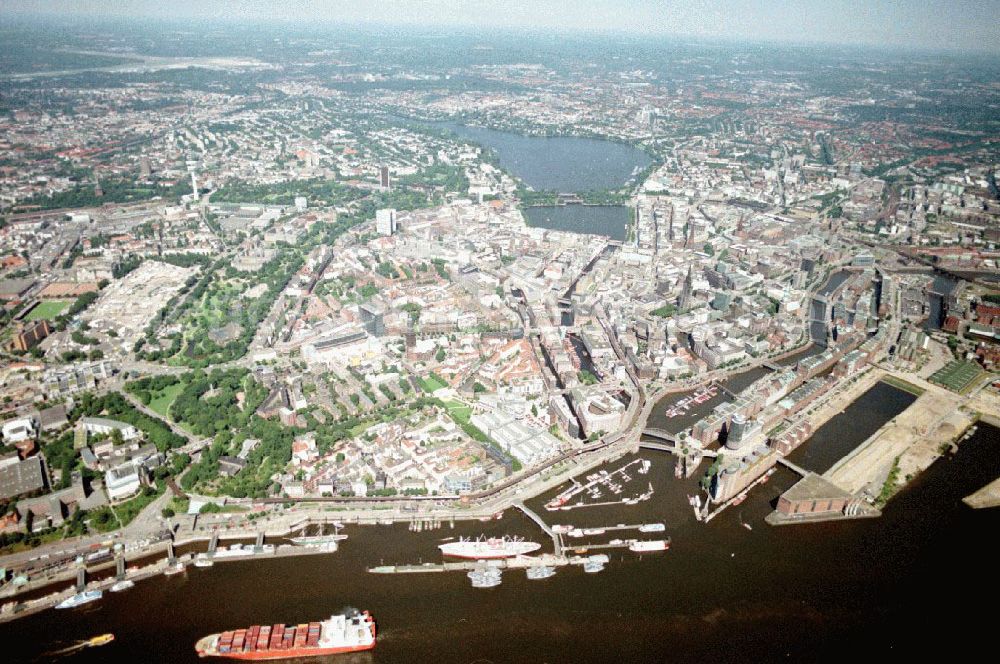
[0,0,1000,52]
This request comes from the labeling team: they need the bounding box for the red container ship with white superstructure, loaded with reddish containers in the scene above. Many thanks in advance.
[194,611,375,660]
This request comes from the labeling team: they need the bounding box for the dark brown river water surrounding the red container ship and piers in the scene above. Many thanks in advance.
[0,395,1000,664]
